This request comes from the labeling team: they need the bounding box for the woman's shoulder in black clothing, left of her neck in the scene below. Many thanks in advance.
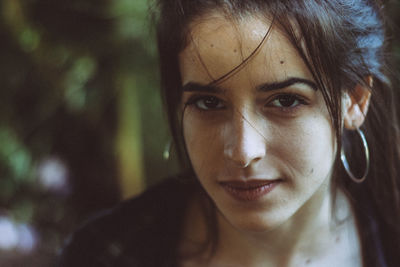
[58,178,197,267]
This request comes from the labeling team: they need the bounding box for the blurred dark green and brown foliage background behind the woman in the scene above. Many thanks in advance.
[0,0,400,267]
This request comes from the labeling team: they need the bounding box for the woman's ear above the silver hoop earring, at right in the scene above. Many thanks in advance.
[344,76,373,130]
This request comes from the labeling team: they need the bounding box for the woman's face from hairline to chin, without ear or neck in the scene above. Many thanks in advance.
[179,13,336,232]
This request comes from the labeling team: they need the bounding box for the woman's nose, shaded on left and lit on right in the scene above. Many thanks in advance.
[224,114,266,168]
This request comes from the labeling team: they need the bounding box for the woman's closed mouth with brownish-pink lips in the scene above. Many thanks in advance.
[219,179,282,201]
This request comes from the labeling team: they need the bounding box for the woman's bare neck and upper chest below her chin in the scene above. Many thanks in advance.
[182,184,354,266]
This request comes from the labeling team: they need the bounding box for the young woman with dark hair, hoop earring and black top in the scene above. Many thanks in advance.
[60,0,400,267]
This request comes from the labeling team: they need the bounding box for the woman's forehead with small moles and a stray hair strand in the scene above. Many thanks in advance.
[179,12,311,84]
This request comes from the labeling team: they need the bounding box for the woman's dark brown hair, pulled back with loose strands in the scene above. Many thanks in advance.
[152,0,400,266]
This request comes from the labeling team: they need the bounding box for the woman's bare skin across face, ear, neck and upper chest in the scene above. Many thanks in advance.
[180,13,372,266]
